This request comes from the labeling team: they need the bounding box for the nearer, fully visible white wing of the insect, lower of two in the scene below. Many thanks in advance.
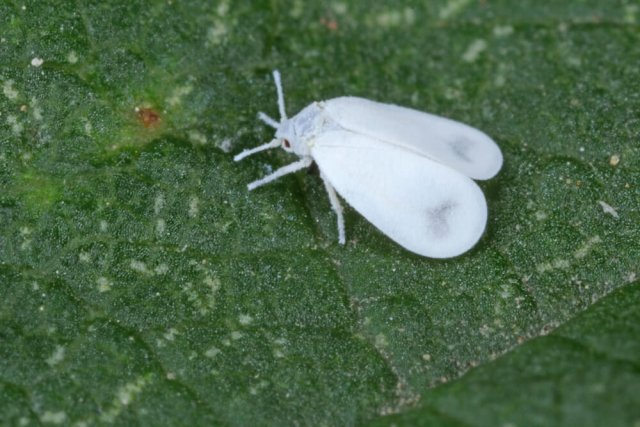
[311,130,487,258]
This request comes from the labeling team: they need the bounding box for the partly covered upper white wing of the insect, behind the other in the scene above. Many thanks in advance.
[324,97,502,179]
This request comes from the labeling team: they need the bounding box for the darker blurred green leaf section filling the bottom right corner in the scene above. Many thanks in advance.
[378,282,640,426]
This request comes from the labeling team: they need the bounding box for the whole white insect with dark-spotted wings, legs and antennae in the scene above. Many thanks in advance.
[234,71,502,258]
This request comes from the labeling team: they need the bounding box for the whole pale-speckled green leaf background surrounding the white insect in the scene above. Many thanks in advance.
[0,0,640,425]
